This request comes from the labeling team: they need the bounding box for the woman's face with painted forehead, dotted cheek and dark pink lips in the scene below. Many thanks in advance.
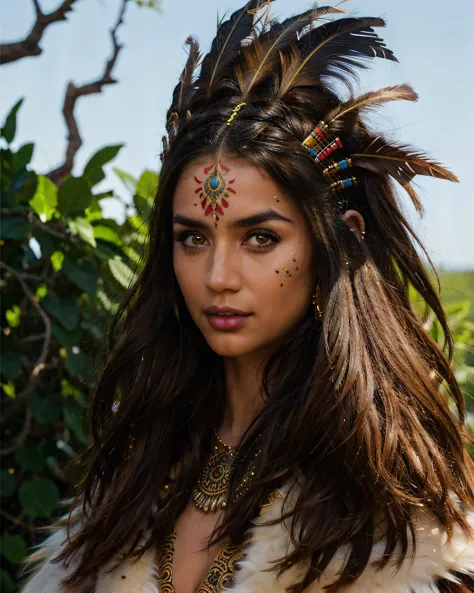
[173,157,315,357]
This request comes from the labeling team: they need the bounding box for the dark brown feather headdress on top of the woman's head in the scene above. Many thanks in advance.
[162,0,458,213]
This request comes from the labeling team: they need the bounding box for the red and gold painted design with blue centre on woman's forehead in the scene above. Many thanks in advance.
[194,162,236,220]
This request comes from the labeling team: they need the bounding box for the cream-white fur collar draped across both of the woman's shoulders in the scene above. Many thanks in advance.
[17,485,474,593]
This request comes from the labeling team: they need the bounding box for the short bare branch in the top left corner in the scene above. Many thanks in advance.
[0,0,77,64]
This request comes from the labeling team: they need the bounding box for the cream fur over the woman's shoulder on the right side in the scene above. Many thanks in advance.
[235,480,474,593]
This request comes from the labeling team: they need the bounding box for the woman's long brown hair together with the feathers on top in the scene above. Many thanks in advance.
[21,2,474,593]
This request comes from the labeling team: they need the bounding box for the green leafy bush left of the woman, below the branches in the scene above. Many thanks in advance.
[0,101,158,593]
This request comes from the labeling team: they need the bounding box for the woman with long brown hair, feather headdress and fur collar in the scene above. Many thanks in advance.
[17,2,474,593]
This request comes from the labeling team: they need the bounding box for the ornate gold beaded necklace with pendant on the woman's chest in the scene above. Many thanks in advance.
[191,429,262,513]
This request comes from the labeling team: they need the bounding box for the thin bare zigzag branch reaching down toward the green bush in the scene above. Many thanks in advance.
[47,0,130,184]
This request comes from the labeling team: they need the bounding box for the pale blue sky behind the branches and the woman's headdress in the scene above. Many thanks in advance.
[0,0,474,269]
